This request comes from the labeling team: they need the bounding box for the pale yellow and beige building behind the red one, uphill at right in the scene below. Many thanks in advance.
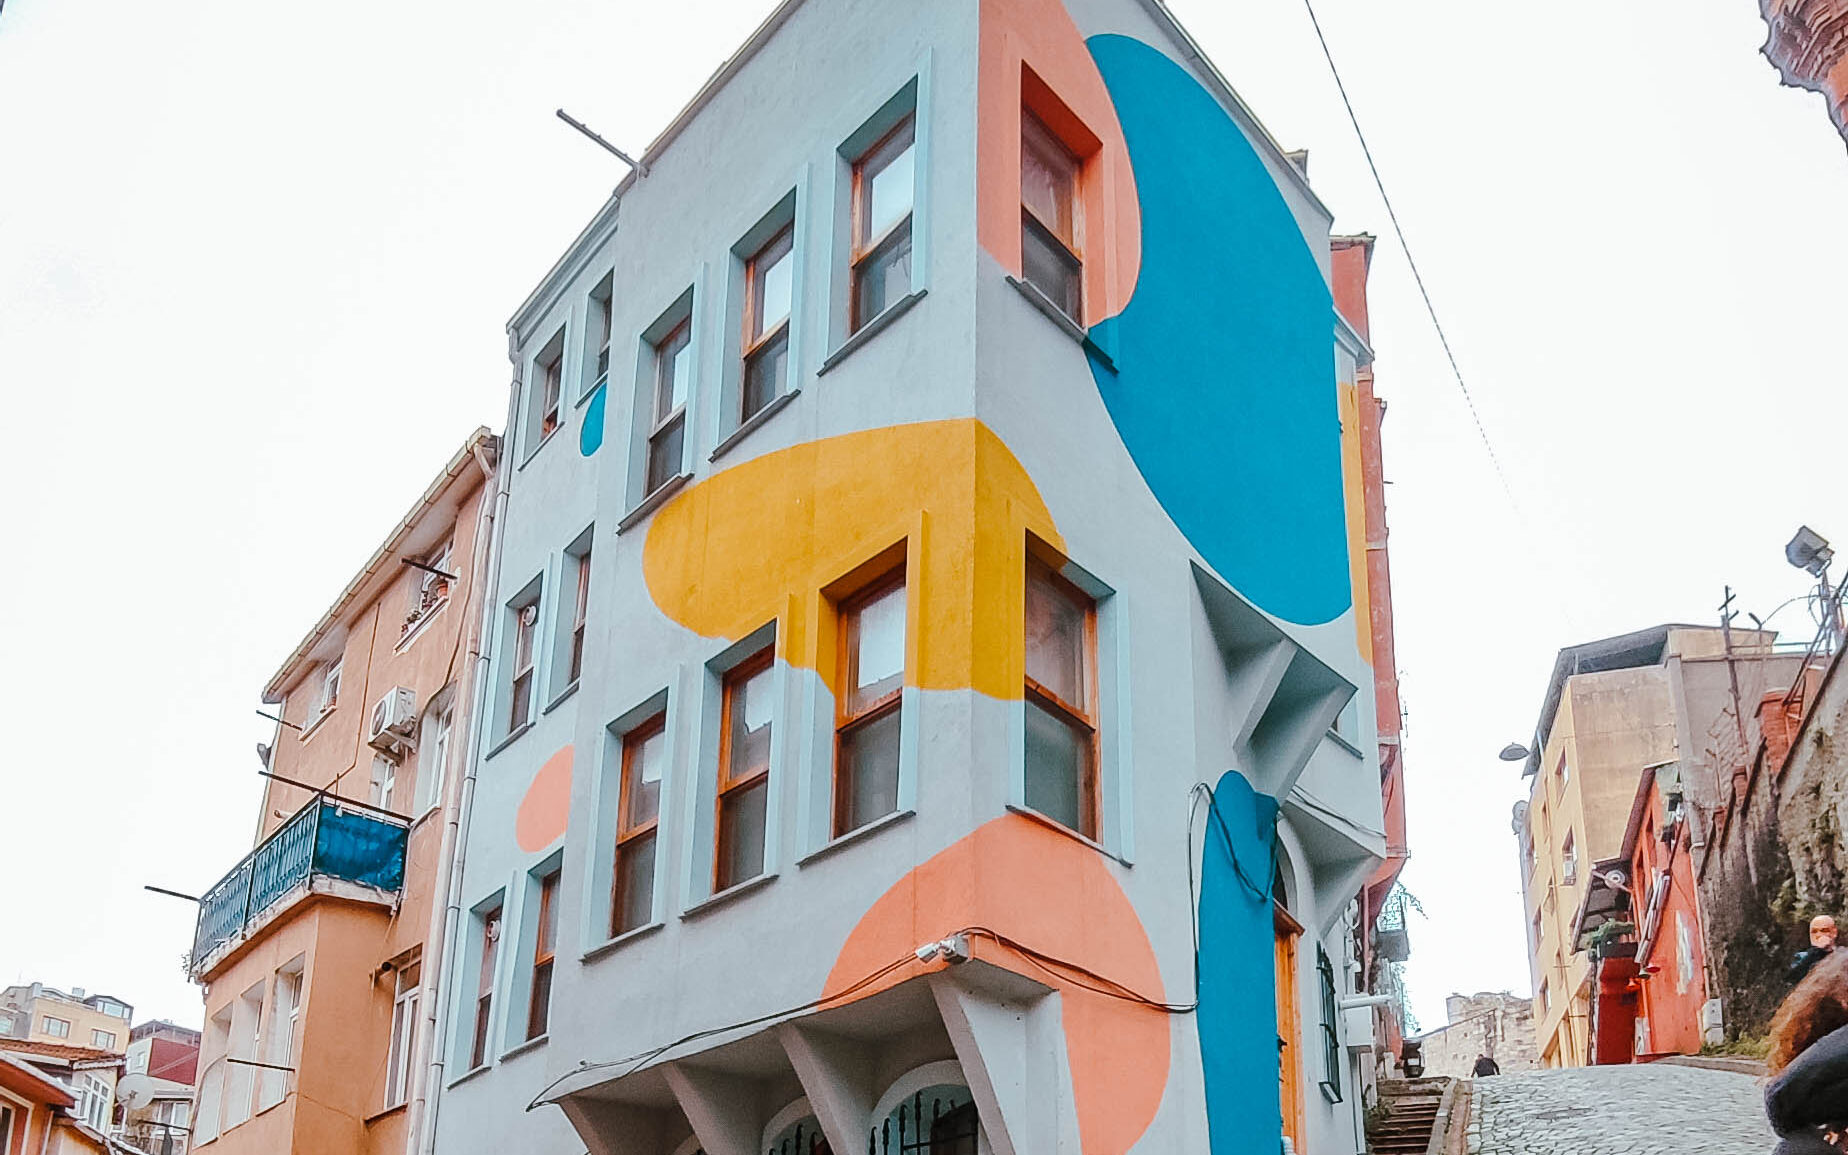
[1515,625,1802,1066]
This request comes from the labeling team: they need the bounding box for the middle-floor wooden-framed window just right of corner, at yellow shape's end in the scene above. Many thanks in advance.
[1026,560,1098,839]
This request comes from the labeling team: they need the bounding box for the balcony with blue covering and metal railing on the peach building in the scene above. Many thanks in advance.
[190,796,408,979]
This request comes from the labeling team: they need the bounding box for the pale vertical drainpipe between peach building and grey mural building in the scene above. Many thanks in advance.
[407,378,519,1155]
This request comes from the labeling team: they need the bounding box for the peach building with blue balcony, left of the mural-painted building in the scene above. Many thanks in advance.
[192,429,499,1155]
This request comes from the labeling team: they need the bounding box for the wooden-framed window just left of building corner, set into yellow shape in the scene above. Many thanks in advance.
[833,573,906,837]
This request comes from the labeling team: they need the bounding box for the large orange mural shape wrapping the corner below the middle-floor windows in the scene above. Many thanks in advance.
[822,815,1172,1155]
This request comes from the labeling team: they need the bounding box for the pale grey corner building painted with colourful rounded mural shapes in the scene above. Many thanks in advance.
[432,0,1403,1155]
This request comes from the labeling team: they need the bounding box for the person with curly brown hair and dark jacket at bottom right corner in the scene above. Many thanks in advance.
[1765,950,1848,1155]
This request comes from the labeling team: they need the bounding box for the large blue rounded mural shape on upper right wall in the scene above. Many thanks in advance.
[1087,35,1353,625]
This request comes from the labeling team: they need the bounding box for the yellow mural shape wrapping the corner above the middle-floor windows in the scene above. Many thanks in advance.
[643,418,1064,699]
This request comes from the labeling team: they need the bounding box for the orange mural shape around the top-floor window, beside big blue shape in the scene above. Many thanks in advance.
[976,0,1142,325]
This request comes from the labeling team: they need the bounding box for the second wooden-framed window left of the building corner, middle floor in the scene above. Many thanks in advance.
[711,649,774,891]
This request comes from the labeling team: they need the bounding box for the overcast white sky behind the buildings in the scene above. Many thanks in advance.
[0,0,1848,1026]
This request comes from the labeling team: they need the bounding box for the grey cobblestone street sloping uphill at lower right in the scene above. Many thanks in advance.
[1469,1064,1776,1155]
